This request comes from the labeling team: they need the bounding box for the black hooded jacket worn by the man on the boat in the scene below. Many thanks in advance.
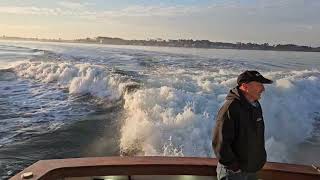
[212,88,267,172]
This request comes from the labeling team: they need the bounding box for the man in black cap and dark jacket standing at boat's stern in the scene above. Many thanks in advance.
[212,71,272,180]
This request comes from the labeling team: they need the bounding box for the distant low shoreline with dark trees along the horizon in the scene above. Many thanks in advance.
[0,36,320,52]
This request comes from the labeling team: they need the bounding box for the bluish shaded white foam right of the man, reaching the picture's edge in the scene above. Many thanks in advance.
[261,70,320,162]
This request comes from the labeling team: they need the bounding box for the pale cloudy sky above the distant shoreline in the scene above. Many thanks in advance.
[0,0,320,47]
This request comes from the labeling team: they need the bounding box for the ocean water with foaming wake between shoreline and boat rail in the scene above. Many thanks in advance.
[0,41,320,179]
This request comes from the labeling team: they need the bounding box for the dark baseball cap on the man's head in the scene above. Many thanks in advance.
[237,71,273,85]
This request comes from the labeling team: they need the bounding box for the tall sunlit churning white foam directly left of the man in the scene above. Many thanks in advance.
[120,86,219,156]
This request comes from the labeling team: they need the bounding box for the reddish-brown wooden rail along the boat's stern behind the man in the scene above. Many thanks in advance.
[11,156,320,180]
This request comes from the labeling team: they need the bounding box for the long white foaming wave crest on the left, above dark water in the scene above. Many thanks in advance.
[12,61,133,100]
